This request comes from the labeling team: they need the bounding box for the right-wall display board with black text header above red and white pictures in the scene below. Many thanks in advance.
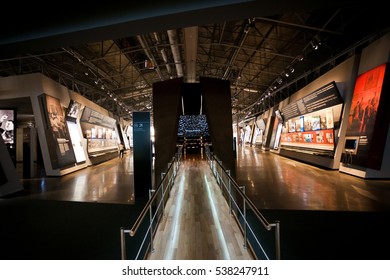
[275,82,343,156]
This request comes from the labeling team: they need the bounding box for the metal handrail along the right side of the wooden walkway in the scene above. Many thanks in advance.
[206,149,280,259]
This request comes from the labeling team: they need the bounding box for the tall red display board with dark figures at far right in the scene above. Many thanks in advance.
[344,64,390,169]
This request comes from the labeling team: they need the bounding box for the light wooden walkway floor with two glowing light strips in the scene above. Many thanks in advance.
[148,156,253,260]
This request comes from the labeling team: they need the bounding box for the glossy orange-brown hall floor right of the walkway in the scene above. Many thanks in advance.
[236,147,390,211]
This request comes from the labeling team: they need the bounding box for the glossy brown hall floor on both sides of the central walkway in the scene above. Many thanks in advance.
[10,146,390,211]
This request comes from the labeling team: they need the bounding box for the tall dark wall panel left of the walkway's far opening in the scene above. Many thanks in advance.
[153,78,183,187]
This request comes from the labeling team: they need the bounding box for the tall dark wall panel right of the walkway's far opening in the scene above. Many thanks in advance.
[200,77,236,179]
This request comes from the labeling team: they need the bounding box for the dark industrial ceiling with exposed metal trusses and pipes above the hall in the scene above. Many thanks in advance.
[0,4,388,122]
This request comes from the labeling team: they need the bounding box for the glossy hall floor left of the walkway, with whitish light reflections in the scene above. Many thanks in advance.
[17,151,135,204]
